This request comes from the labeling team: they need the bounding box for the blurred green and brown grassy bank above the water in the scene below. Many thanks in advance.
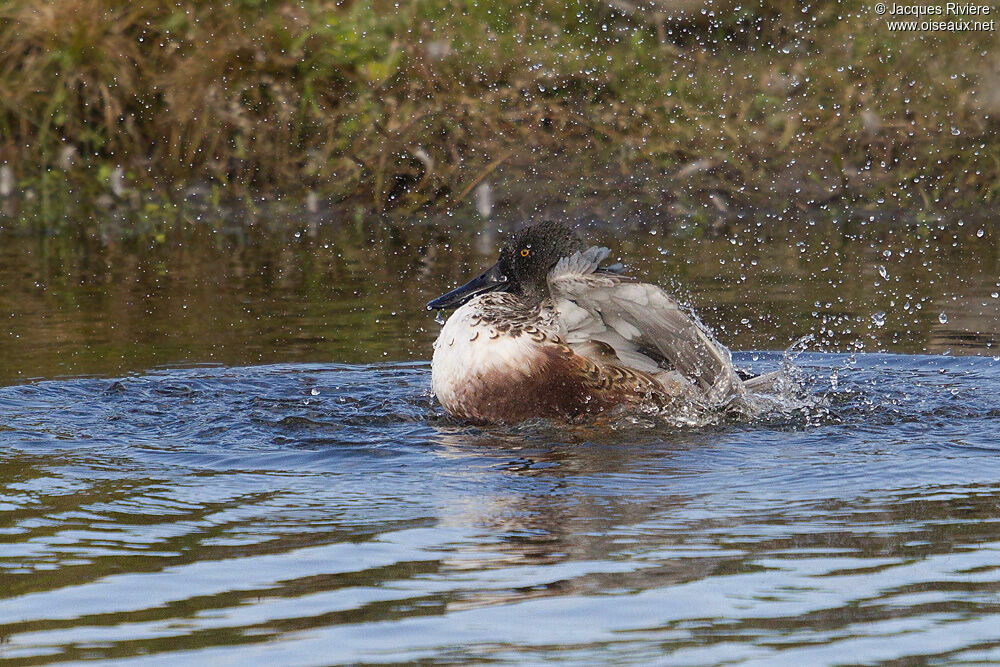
[0,0,1000,212]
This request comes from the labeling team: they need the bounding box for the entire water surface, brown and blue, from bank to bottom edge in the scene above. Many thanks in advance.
[0,214,1000,664]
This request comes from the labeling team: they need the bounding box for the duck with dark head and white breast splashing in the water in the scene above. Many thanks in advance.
[427,220,747,424]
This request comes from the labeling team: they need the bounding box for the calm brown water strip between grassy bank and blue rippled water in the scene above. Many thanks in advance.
[0,209,1000,383]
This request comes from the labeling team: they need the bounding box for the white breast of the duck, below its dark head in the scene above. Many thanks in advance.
[431,297,552,412]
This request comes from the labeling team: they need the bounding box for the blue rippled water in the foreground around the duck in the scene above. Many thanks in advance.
[0,355,1000,664]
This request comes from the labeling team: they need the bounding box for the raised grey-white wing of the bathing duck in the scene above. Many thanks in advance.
[548,247,742,401]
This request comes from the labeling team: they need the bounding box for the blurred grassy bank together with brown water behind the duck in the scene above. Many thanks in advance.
[0,0,1000,380]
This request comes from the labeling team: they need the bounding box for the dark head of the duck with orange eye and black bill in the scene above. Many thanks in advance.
[427,220,583,310]
